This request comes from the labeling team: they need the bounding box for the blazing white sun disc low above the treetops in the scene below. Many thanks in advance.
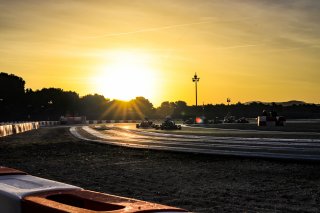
[94,51,157,101]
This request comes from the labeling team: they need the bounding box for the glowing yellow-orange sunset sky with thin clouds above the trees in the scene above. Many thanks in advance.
[0,0,320,106]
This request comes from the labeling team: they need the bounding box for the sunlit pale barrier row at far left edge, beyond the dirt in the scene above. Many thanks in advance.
[0,122,40,137]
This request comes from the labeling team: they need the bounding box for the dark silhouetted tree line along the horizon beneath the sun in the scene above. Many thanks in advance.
[0,73,320,122]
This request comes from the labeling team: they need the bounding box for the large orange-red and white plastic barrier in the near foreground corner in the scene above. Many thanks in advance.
[0,167,187,213]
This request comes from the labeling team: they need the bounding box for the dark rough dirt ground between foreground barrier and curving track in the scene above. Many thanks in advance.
[0,128,320,212]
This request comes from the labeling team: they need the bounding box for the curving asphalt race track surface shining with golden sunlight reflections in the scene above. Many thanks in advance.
[70,124,320,161]
